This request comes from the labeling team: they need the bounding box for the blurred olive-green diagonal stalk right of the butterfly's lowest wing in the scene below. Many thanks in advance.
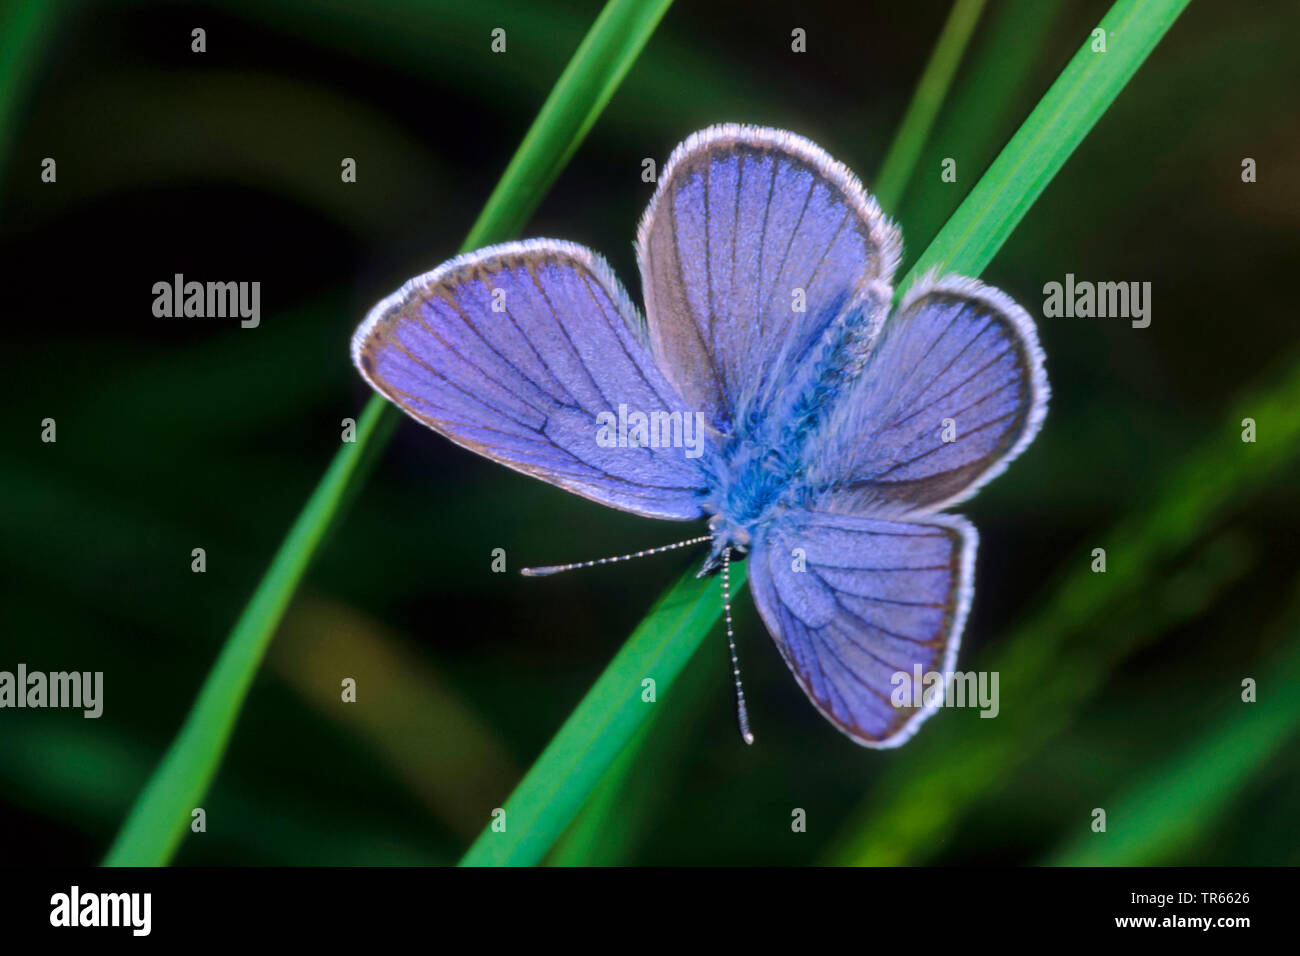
[837,340,1300,864]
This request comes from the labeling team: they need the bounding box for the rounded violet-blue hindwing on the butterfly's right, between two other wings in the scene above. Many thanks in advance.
[806,276,1048,516]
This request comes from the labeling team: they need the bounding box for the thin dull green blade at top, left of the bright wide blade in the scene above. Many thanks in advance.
[872,0,984,216]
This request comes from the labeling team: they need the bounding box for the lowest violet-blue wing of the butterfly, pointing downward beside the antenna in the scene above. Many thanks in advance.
[749,511,978,748]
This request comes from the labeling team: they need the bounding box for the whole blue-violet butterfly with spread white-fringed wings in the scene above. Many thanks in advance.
[352,125,1048,747]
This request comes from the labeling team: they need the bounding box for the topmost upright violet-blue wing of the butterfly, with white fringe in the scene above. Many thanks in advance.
[637,125,900,433]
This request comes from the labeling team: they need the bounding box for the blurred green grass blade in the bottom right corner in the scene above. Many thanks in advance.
[1047,621,1300,866]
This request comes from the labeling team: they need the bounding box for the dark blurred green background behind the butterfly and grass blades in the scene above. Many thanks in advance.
[0,0,1300,864]
